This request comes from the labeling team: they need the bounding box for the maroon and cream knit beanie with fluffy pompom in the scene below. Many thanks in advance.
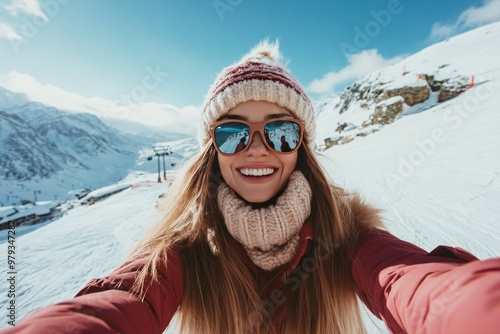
[199,40,315,148]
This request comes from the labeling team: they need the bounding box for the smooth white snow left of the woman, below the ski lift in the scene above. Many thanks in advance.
[0,174,166,326]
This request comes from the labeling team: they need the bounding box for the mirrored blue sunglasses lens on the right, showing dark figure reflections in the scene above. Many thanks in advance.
[264,121,300,152]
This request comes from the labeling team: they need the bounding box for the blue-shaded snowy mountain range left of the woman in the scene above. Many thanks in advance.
[0,87,195,206]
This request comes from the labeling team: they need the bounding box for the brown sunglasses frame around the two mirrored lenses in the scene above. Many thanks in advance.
[210,117,305,156]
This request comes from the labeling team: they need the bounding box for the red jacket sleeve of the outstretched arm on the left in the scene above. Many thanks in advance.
[0,253,183,334]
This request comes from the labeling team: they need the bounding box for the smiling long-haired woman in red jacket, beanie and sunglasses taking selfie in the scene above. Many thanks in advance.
[2,42,500,334]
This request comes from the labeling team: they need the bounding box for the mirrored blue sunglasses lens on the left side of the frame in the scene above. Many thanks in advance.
[214,122,250,154]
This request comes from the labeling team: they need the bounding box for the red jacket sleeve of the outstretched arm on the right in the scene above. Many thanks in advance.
[352,230,500,334]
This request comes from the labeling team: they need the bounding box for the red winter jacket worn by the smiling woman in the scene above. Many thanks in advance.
[0,223,500,334]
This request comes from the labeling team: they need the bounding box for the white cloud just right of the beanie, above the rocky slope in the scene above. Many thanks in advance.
[308,49,403,94]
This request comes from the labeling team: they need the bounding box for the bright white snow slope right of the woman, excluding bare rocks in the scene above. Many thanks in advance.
[318,23,500,258]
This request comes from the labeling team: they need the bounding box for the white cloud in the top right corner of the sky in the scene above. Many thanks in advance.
[430,0,500,40]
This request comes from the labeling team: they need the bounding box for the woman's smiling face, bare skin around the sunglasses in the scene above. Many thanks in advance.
[218,101,298,203]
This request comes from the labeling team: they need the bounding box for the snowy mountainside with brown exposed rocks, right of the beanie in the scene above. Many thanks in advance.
[315,23,500,150]
